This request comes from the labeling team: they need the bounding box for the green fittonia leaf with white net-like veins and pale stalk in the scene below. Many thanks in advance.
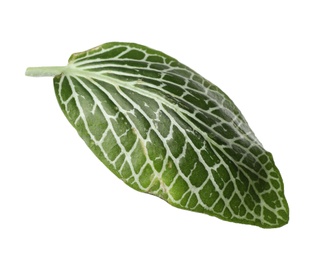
[26,42,289,228]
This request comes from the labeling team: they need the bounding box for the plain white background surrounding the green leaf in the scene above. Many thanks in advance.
[0,0,321,260]
